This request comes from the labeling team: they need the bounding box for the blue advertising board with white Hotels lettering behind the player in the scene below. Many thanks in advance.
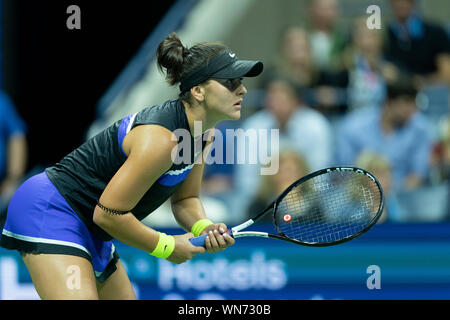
[0,224,450,300]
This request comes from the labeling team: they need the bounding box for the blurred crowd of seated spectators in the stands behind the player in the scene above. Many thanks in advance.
[0,0,450,225]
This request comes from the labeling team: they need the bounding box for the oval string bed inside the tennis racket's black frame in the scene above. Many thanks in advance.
[274,171,381,243]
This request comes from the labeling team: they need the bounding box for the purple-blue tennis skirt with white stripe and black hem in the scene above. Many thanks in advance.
[0,172,119,282]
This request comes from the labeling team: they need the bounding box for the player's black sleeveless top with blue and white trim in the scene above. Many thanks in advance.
[46,100,206,241]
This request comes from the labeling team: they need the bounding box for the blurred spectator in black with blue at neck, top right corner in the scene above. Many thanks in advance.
[384,0,450,88]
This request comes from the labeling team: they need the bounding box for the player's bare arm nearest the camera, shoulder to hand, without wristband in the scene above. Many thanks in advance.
[93,125,204,263]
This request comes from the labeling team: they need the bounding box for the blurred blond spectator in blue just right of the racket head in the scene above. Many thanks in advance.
[355,152,407,223]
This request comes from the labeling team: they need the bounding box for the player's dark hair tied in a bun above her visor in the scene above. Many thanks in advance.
[156,32,228,100]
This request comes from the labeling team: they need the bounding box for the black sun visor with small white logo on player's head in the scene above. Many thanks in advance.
[180,50,263,92]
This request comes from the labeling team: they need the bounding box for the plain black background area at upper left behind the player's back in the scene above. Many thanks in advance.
[3,0,174,169]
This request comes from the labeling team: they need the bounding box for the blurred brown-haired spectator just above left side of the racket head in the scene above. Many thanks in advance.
[247,149,310,217]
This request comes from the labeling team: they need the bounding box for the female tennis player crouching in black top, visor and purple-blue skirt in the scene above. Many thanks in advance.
[1,33,263,299]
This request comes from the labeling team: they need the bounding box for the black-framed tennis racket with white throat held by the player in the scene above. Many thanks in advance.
[190,167,384,247]
